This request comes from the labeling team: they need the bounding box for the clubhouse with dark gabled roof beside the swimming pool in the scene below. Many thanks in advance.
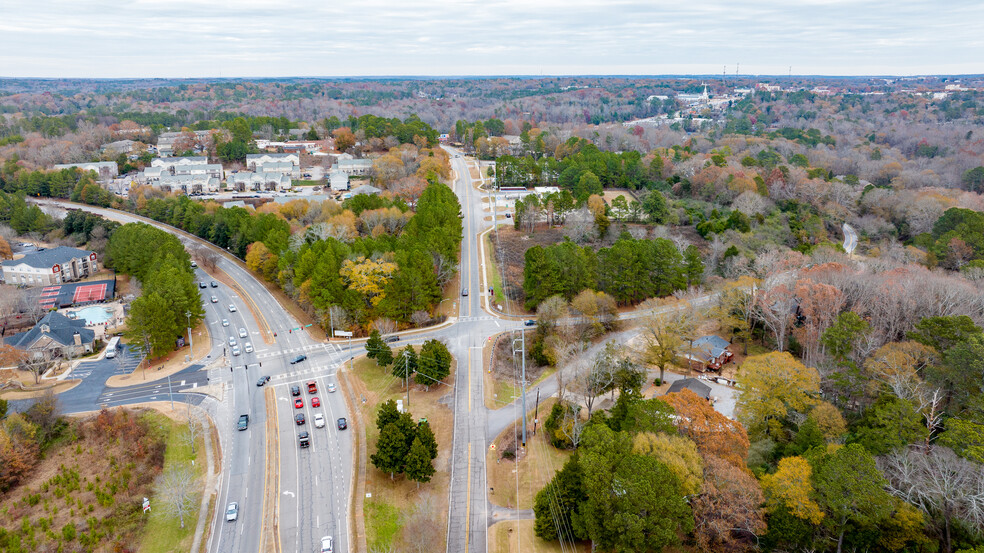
[4,311,96,359]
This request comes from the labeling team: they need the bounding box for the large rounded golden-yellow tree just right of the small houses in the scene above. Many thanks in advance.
[735,351,820,437]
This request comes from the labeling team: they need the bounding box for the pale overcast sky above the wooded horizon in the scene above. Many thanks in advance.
[0,0,984,77]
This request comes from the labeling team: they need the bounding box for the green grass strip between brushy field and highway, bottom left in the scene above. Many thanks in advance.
[139,412,205,553]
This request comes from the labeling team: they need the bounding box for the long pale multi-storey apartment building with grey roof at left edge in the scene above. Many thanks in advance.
[0,246,99,286]
